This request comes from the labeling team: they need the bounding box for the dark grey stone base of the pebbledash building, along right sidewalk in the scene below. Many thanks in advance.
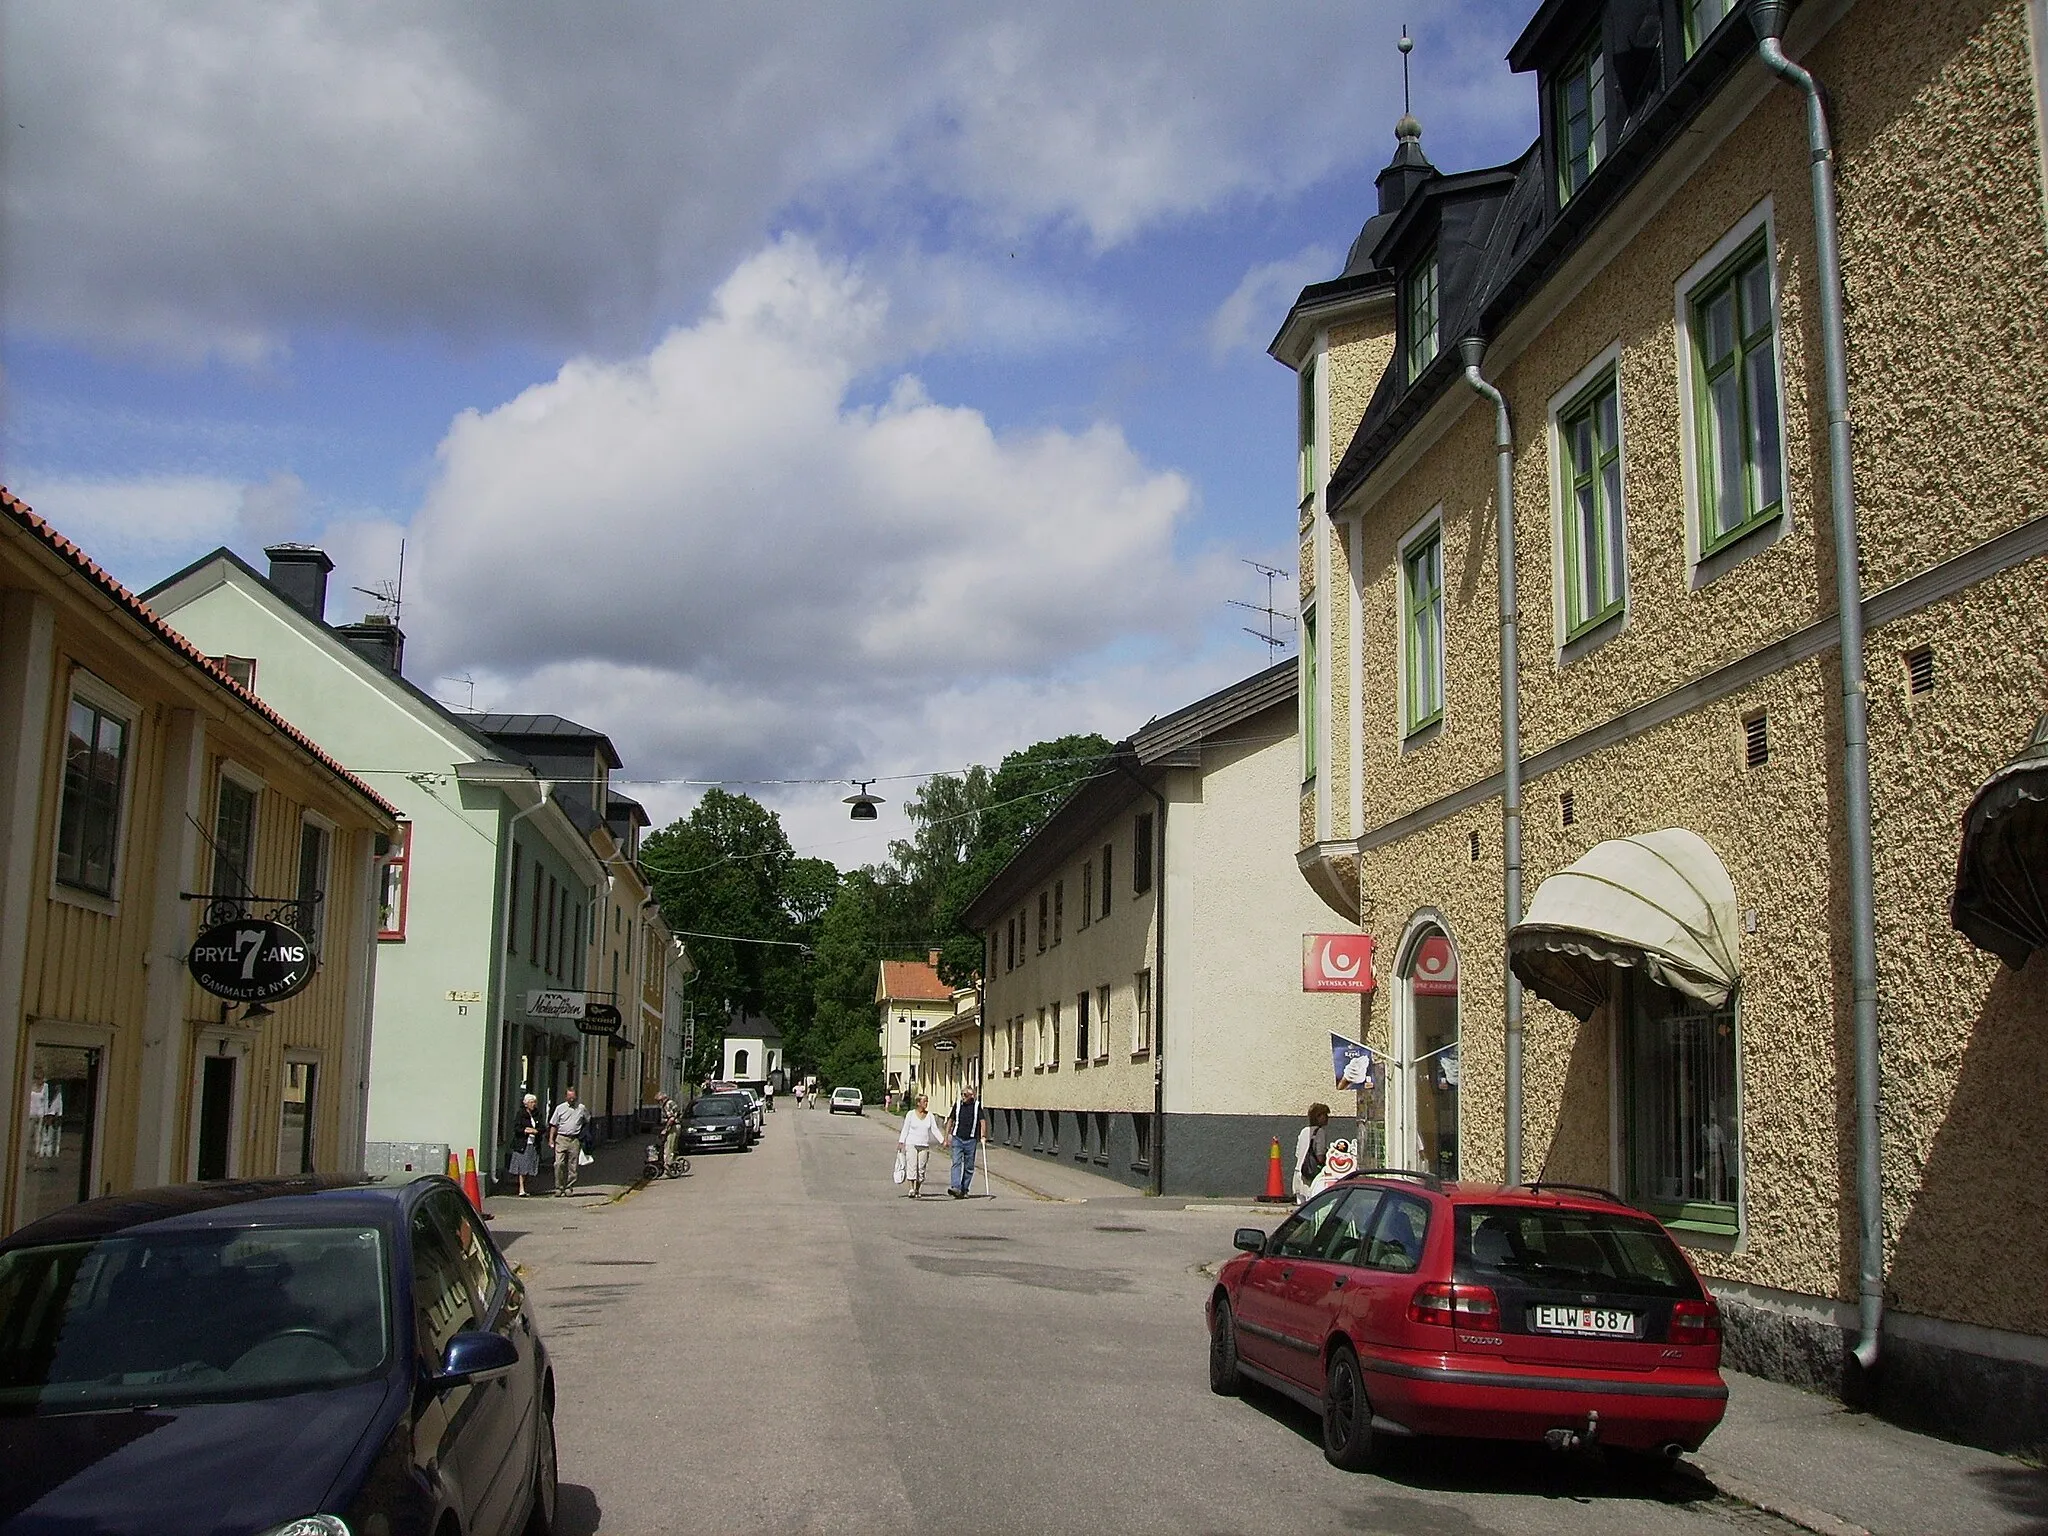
[1714,1286,2048,1458]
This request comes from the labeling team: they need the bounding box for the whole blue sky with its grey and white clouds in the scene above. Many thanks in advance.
[0,0,1534,862]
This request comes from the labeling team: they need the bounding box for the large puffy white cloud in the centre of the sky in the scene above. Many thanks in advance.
[387,240,1260,860]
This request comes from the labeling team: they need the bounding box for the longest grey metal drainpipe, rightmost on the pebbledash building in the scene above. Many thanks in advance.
[1749,0,1884,1370]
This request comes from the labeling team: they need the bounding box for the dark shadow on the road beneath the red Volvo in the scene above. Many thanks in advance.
[1241,1382,1720,1503]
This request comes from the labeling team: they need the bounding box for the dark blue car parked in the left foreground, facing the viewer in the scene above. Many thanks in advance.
[0,1178,555,1536]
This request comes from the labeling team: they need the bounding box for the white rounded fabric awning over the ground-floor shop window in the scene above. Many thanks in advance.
[1507,827,1741,1020]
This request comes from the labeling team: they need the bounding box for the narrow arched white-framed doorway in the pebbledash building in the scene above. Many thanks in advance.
[1386,920,1462,1178]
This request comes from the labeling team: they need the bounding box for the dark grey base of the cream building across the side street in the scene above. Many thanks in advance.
[989,1108,1307,1200]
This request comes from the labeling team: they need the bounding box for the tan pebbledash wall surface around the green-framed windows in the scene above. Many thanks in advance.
[1276,0,2048,1448]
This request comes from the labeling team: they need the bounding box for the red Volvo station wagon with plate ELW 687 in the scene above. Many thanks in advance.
[1208,1169,1729,1470]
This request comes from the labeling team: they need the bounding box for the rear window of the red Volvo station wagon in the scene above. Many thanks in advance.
[1458,1206,1700,1300]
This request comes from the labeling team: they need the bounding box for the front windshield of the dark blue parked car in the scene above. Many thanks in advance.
[0,1227,391,1413]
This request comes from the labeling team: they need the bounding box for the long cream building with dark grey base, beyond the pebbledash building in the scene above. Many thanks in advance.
[967,662,1360,1196]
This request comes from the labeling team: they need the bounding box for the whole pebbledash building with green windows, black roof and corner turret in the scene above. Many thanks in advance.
[1272,0,2048,1446]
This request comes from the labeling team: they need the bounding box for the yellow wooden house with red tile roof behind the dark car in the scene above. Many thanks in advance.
[0,489,397,1231]
